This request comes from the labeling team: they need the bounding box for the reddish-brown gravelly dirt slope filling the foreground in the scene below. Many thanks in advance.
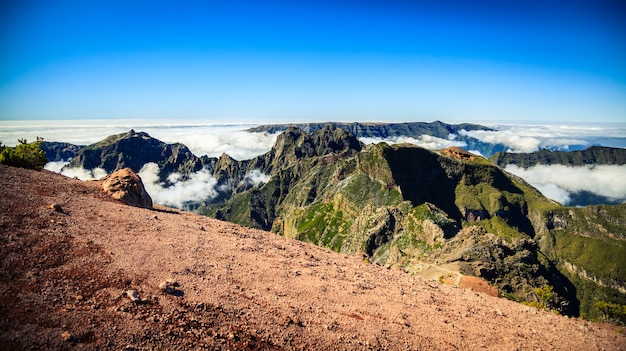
[0,166,626,350]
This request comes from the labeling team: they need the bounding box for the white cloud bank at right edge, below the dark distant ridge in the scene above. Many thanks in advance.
[505,165,626,205]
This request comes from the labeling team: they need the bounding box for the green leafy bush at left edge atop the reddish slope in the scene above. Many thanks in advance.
[0,137,48,171]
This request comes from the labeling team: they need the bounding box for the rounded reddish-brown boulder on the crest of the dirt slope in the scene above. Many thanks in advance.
[102,168,152,208]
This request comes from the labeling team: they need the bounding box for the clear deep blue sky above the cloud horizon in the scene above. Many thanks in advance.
[0,0,626,123]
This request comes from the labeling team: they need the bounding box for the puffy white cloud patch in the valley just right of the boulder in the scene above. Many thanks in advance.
[139,162,218,208]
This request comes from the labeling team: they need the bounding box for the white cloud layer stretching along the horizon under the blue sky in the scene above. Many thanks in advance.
[0,119,626,160]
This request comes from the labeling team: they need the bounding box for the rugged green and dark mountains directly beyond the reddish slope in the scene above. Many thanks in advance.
[43,124,626,323]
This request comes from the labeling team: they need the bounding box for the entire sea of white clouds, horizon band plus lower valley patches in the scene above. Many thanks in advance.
[0,120,626,207]
